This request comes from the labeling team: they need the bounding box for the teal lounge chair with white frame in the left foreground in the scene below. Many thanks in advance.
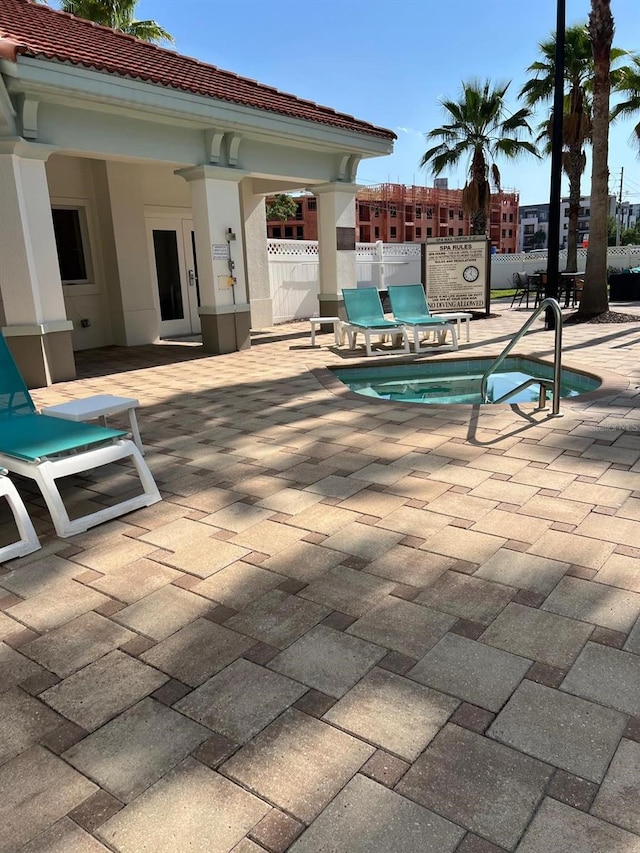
[0,335,161,538]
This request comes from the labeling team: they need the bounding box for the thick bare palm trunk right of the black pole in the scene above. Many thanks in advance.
[578,0,615,316]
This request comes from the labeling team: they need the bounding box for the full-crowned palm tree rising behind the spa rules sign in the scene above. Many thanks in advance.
[420,80,538,234]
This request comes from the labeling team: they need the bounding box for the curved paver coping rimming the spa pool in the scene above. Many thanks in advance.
[311,354,631,411]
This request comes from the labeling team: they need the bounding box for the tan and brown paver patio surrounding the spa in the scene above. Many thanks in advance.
[0,305,640,853]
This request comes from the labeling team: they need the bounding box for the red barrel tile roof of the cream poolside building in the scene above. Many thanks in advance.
[0,0,395,139]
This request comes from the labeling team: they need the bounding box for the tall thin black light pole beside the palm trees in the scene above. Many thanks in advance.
[545,0,566,329]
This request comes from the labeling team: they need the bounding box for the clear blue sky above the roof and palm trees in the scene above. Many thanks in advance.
[96,0,640,204]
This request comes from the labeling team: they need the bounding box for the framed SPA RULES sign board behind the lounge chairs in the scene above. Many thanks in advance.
[425,236,489,311]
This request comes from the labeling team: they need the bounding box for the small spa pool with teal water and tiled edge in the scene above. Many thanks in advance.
[332,356,601,405]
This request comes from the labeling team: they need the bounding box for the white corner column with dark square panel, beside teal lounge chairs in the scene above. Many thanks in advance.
[310,182,358,320]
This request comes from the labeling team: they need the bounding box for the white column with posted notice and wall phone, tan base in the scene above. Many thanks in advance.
[176,166,252,355]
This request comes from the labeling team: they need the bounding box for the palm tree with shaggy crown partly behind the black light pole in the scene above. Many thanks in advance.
[519,24,626,272]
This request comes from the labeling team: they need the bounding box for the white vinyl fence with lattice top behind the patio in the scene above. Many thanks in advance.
[267,240,640,323]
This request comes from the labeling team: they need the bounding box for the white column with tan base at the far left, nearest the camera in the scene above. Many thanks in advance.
[0,139,76,388]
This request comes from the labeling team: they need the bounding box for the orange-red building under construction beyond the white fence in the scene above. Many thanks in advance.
[267,180,519,254]
